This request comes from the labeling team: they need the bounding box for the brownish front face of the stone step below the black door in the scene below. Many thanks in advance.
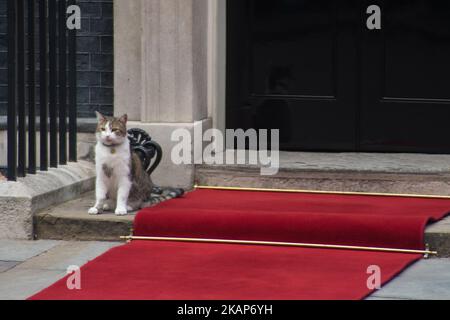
[195,165,450,196]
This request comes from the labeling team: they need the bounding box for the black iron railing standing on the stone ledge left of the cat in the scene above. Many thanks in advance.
[7,0,77,181]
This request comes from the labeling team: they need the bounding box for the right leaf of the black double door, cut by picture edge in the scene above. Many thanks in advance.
[360,0,450,153]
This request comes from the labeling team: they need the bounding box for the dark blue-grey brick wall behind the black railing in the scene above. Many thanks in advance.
[0,0,114,118]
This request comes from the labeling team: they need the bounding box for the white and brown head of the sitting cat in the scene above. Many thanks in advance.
[96,112,128,146]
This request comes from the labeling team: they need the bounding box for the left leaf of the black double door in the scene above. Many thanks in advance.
[227,0,358,150]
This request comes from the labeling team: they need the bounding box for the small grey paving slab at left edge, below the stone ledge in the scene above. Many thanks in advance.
[0,240,58,261]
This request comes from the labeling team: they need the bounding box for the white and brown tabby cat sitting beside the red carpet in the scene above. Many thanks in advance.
[89,112,183,216]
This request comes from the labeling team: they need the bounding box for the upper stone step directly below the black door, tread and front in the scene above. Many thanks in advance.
[195,152,450,195]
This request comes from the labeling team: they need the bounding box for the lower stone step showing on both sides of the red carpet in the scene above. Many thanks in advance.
[34,193,450,258]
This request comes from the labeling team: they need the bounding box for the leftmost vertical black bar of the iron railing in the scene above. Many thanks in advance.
[7,0,17,181]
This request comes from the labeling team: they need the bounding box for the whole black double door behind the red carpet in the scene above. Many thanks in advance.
[227,0,450,153]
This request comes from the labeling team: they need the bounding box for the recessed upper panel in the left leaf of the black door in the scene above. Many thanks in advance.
[250,0,336,98]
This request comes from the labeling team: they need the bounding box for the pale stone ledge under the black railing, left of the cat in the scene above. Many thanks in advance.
[0,161,95,239]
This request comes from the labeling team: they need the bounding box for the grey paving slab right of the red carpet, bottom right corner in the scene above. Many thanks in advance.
[371,259,450,300]
